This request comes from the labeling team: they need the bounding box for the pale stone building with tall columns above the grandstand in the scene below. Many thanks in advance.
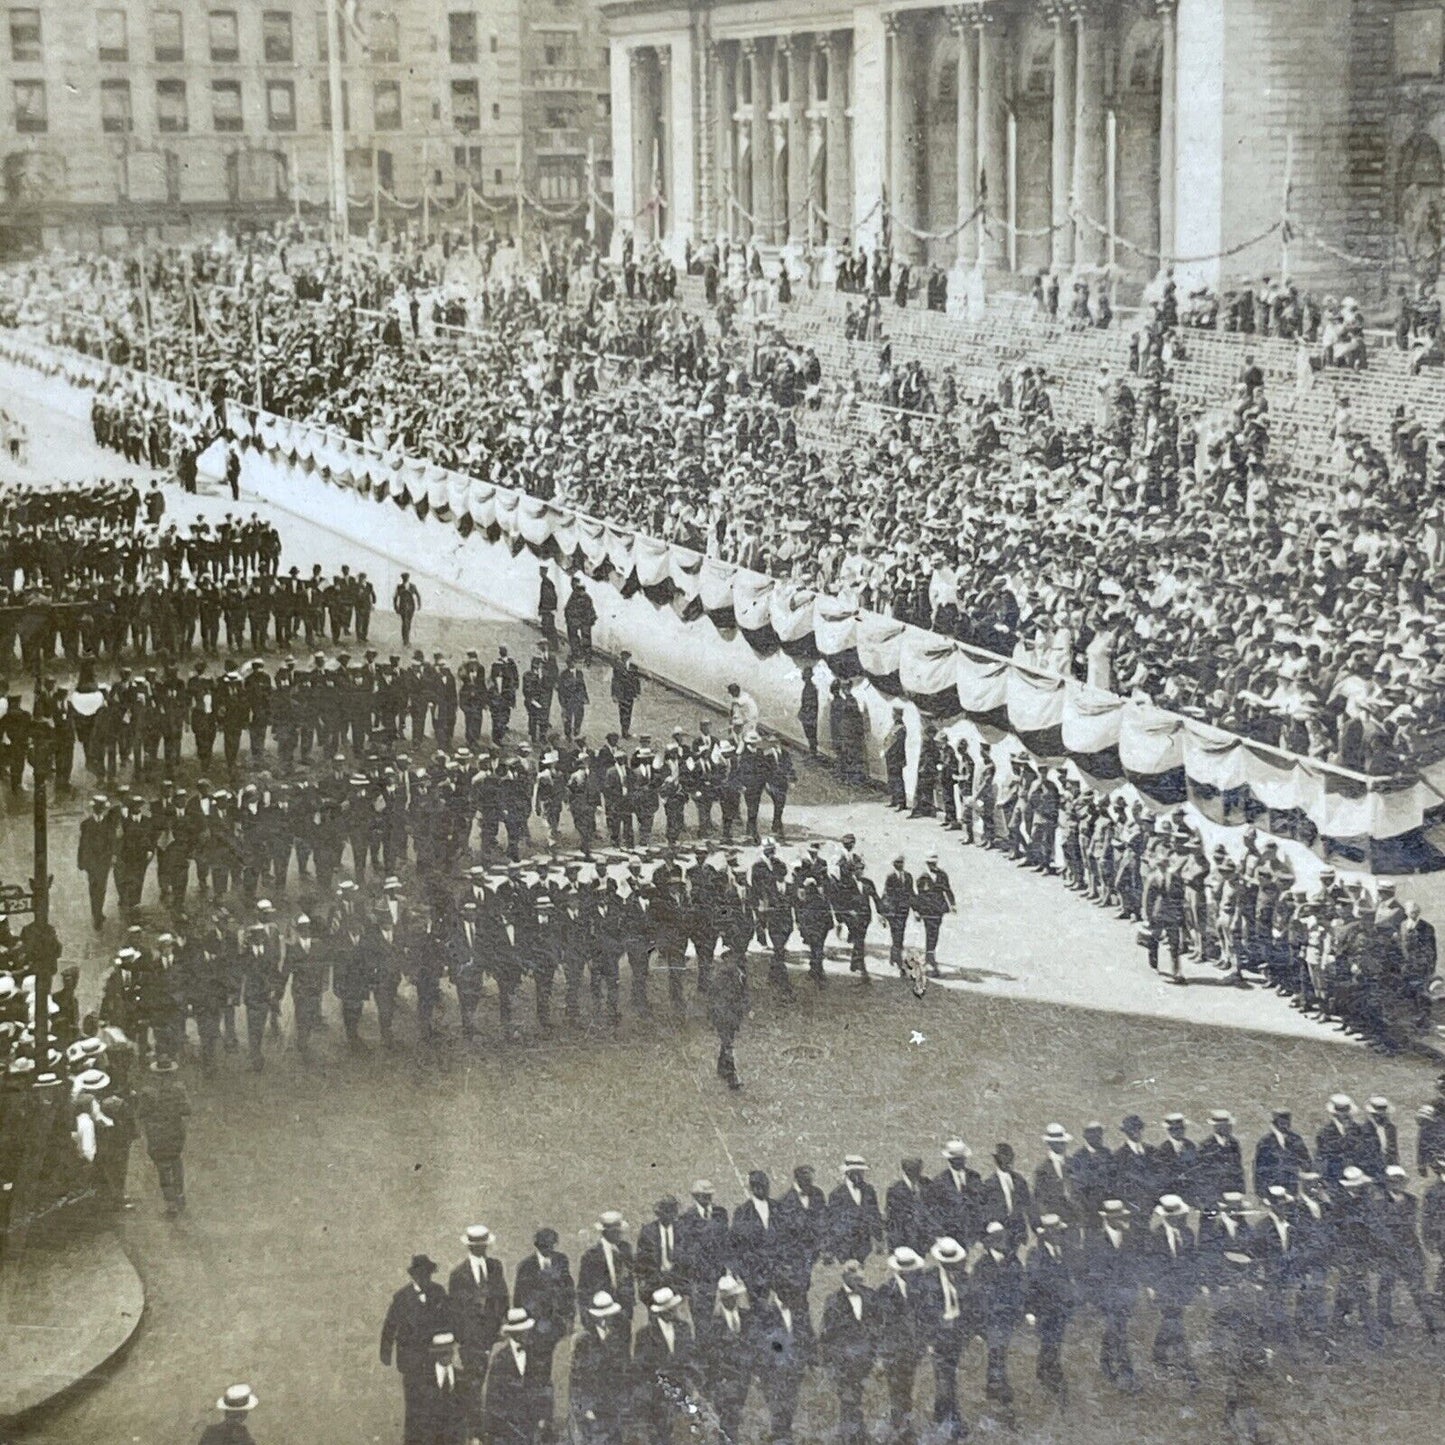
[603,0,1445,298]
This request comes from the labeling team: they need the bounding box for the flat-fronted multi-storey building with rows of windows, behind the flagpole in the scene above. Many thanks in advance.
[0,0,610,249]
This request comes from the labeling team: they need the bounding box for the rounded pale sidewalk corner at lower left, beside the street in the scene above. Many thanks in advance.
[0,1230,146,1426]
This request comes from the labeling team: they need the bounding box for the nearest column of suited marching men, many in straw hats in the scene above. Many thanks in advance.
[367,1077,1445,1445]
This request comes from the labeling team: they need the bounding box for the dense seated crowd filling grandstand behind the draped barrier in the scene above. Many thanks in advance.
[12,225,1445,773]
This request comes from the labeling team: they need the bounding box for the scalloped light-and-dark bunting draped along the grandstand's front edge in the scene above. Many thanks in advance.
[230,403,1445,847]
